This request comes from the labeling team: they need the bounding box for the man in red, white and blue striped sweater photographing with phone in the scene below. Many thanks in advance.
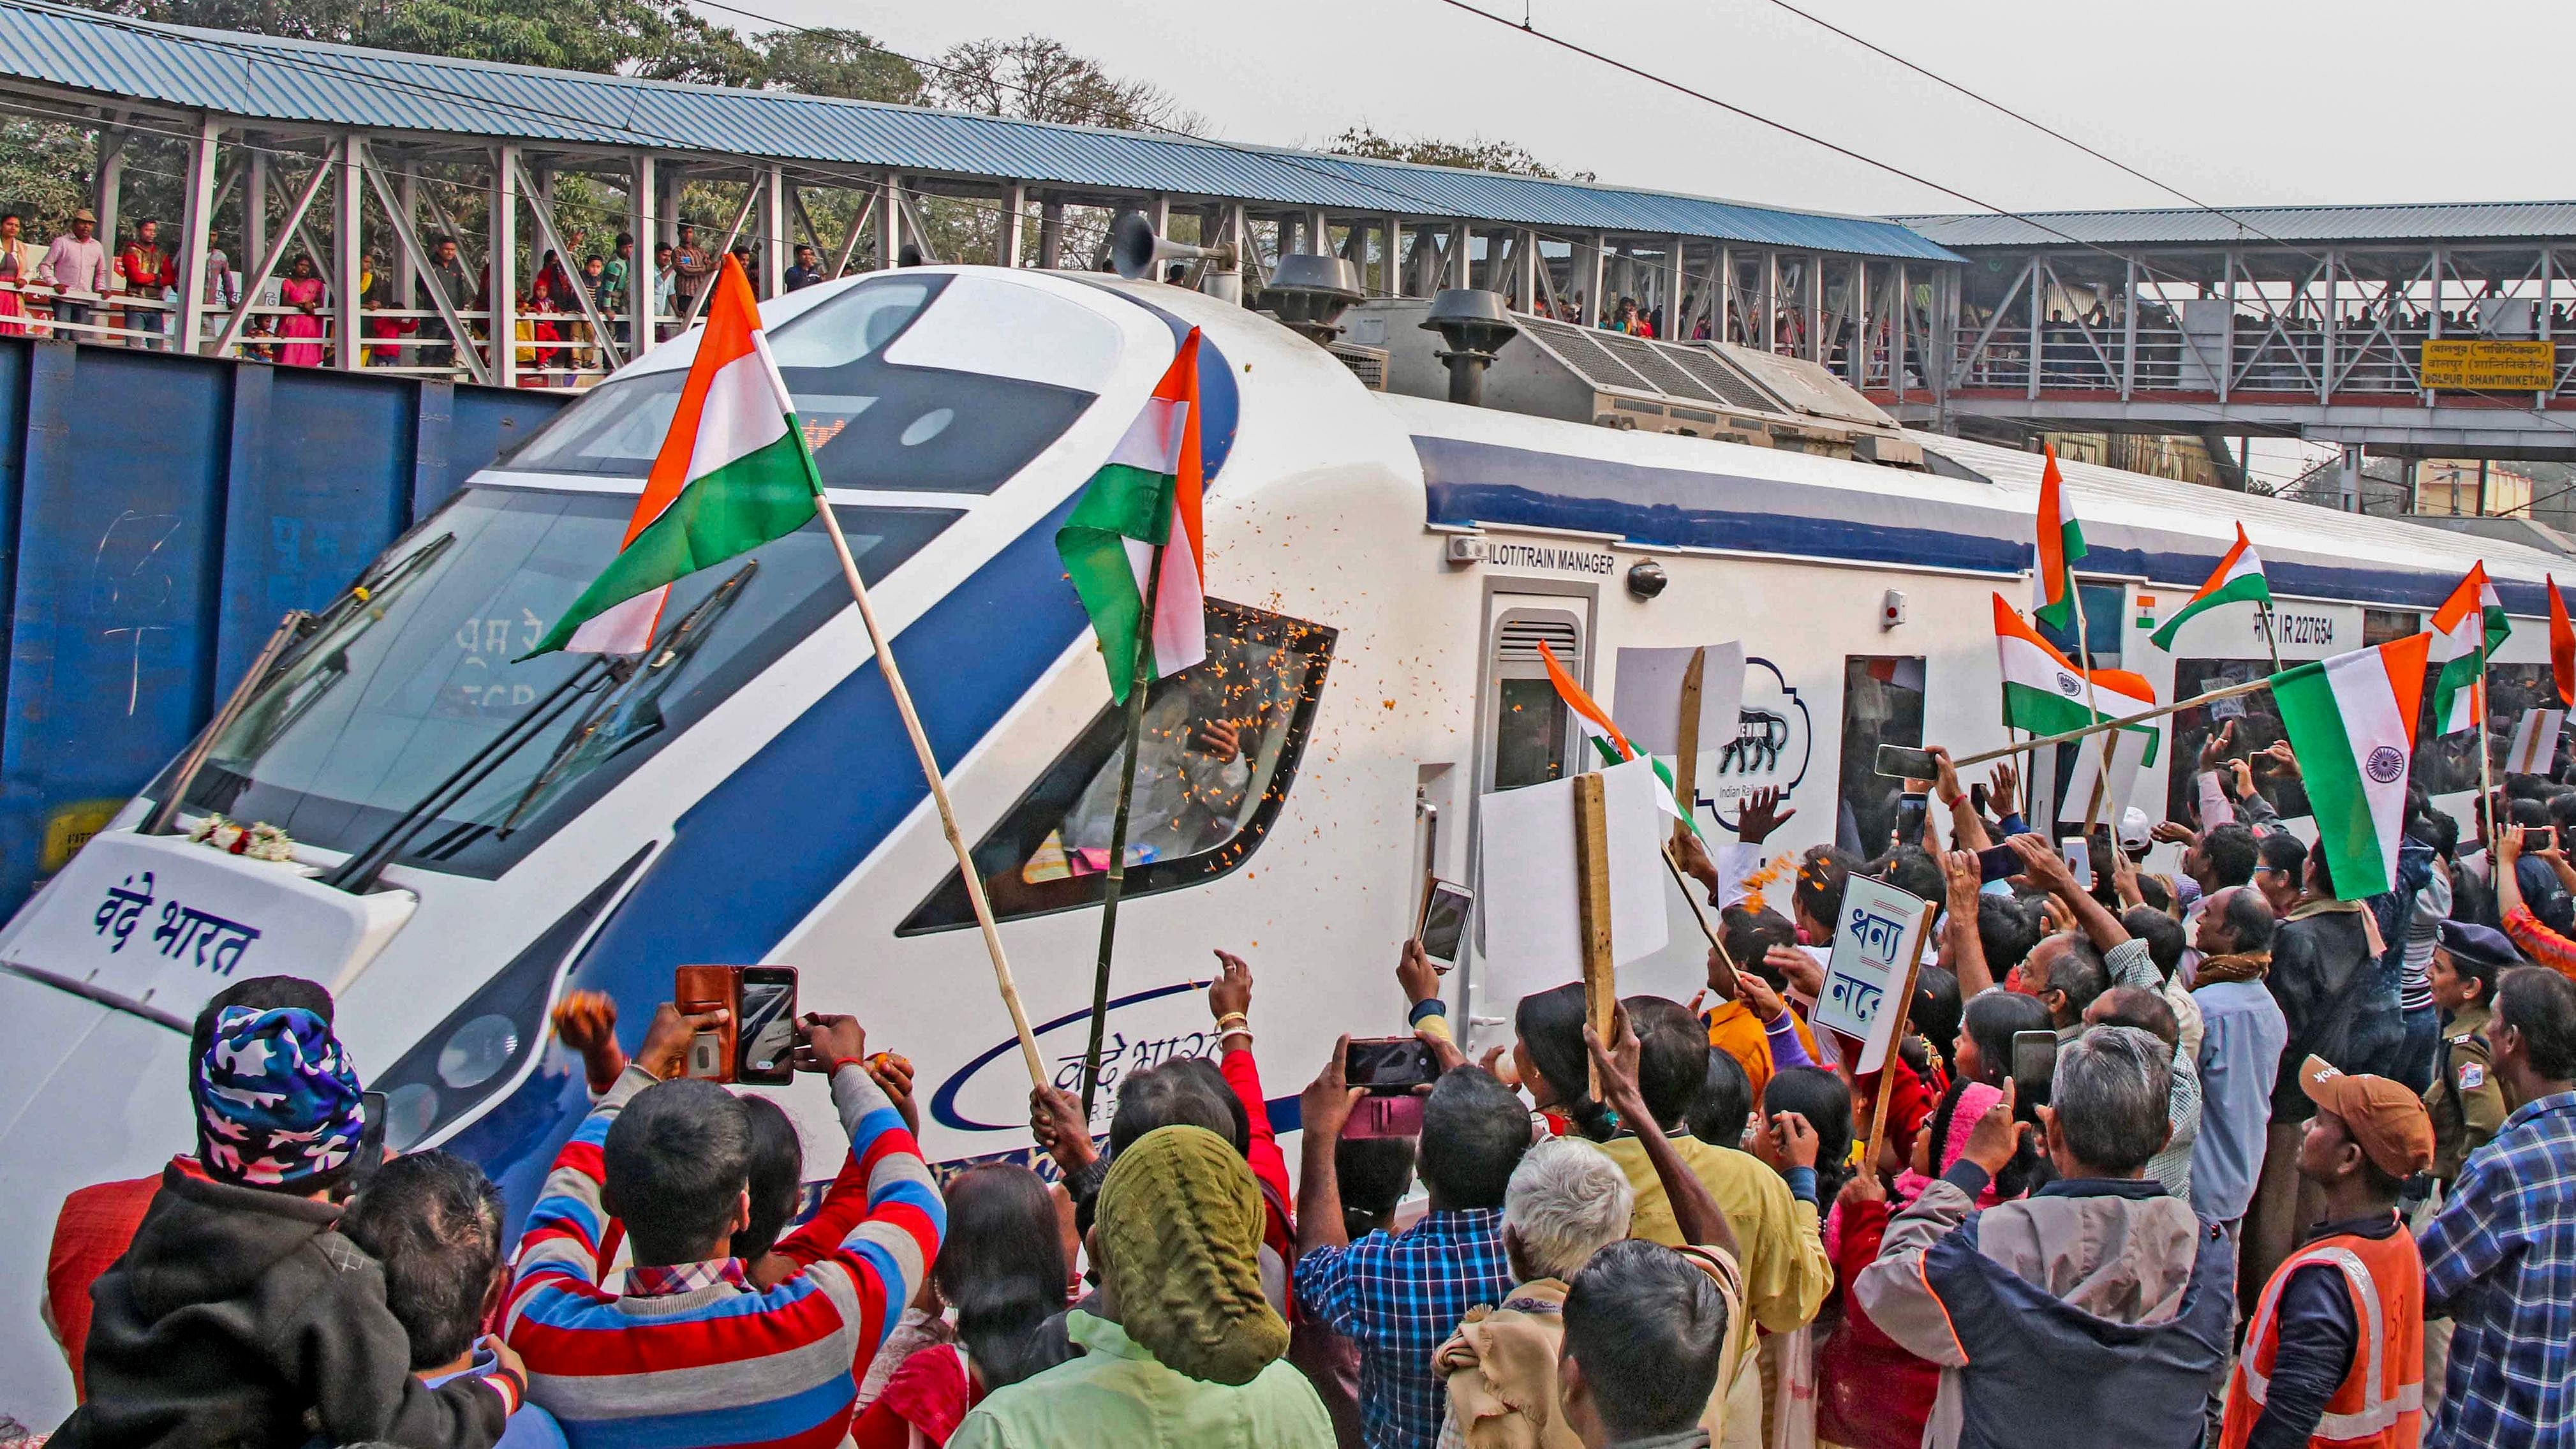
[502,1000,948,1444]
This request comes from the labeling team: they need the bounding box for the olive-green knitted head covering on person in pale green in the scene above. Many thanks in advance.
[1095,1127,1288,1385]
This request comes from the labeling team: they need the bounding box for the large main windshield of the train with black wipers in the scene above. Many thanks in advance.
[154,487,956,877]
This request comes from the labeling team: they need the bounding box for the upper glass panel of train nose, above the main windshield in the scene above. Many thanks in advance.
[500,273,1115,493]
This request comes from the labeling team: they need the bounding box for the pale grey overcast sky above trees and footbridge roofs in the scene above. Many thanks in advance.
[719,0,2576,214]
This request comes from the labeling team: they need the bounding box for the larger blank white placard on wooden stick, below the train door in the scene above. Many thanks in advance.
[1476,758,1672,1013]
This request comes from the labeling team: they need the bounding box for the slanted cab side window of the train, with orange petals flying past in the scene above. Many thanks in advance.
[896,598,1335,936]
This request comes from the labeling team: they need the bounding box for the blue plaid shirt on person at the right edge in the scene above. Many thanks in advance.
[2417,1093,2576,1449]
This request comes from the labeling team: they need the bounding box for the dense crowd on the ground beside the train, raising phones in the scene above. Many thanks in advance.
[15,722,2576,1449]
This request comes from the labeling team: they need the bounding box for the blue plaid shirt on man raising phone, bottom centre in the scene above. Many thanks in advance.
[1296,1207,1512,1449]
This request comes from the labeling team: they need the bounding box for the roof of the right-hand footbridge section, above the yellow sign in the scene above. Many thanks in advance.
[1899,201,2576,248]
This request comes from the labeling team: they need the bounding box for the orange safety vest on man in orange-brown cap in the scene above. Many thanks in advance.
[2218,1227,2424,1449]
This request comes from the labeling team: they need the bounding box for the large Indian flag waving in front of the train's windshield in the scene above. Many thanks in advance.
[521,258,822,657]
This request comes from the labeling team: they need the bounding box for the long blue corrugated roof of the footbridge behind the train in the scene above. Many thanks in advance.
[0,0,1958,260]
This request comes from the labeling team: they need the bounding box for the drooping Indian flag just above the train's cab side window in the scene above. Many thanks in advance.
[1056,327,1208,701]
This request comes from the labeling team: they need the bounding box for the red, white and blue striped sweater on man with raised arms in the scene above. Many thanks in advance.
[502,1065,948,1449]
